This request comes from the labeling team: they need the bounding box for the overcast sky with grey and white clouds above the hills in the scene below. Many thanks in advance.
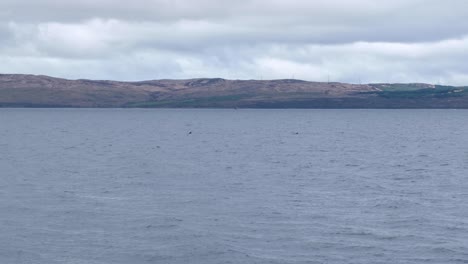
[0,0,468,85]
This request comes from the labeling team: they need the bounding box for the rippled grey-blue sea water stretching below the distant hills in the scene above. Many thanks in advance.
[0,109,468,264]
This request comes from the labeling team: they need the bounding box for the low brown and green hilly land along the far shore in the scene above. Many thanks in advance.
[0,74,468,108]
